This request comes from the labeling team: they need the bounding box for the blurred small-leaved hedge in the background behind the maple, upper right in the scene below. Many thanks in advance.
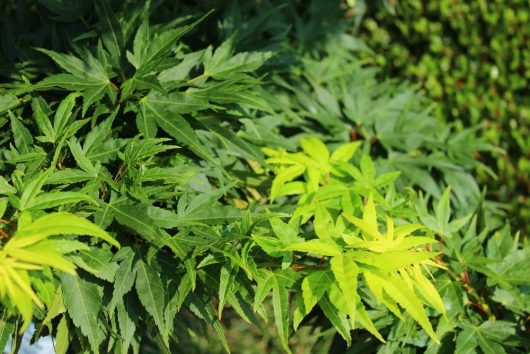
[357,0,530,238]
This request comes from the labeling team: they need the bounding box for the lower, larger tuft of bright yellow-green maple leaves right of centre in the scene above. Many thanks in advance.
[278,188,445,342]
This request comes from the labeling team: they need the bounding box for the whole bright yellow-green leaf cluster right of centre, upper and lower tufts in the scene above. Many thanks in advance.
[255,137,445,343]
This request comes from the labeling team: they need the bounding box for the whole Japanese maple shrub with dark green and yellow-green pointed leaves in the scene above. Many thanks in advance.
[0,0,530,353]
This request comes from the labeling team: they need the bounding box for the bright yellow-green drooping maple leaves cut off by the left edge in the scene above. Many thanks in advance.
[0,212,119,333]
